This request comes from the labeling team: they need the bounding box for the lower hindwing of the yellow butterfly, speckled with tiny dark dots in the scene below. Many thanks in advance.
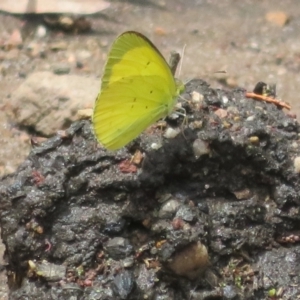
[93,77,168,150]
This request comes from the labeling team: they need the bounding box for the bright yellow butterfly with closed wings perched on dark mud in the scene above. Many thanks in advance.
[92,31,184,150]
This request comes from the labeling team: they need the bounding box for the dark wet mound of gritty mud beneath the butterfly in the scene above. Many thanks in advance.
[0,80,300,300]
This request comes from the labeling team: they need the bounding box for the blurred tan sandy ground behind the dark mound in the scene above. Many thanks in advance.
[0,0,300,299]
